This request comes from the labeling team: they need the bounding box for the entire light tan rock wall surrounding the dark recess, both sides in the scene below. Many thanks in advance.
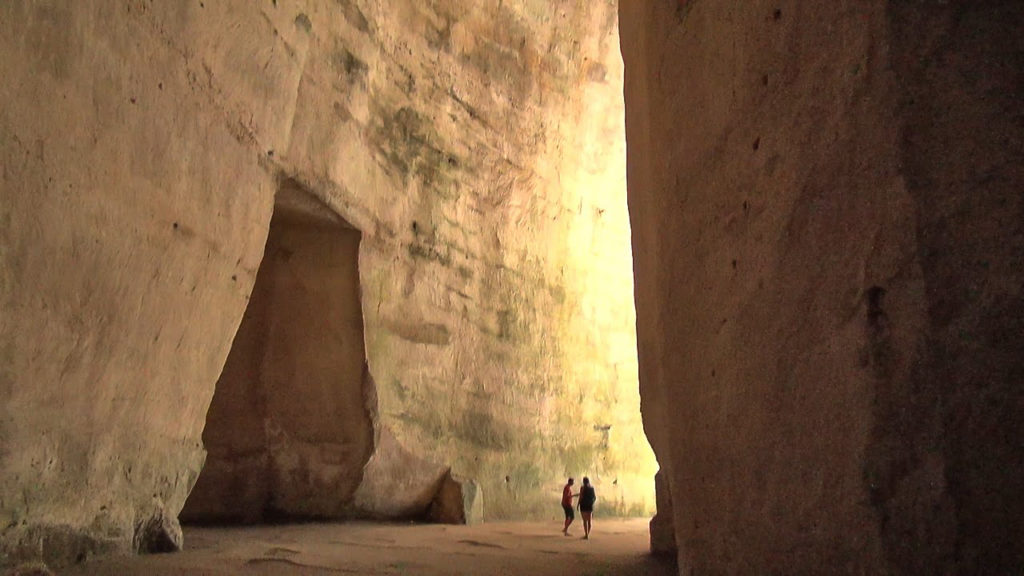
[0,0,655,561]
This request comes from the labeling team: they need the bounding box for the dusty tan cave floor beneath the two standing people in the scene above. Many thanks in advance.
[60,519,675,576]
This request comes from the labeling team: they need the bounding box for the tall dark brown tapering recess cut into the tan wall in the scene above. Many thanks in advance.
[180,179,373,524]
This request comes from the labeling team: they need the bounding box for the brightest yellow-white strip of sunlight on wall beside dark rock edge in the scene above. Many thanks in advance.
[551,7,657,516]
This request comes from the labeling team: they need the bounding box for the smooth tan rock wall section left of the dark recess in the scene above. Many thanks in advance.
[0,1,288,562]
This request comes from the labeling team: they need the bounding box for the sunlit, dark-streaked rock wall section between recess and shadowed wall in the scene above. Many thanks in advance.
[274,1,655,519]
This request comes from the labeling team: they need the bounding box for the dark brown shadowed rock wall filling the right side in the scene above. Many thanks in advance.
[621,0,1024,574]
